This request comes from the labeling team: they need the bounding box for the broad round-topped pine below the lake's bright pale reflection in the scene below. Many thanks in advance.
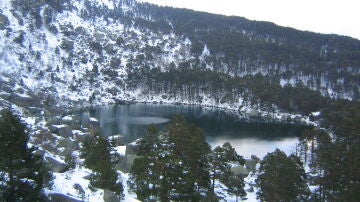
[256,149,309,201]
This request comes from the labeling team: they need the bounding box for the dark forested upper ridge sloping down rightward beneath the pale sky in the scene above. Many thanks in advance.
[76,0,360,99]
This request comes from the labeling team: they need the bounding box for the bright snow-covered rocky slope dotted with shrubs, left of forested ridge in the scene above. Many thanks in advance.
[0,1,197,109]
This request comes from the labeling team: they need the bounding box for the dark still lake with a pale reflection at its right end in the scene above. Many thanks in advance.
[81,103,306,157]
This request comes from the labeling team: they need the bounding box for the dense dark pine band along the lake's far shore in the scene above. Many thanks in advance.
[128,68,331,115]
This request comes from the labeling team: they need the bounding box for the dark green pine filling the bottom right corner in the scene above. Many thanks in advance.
[310,129,360,201]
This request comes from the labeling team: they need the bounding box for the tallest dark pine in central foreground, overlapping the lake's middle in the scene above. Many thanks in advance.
[168,116,211,201]
